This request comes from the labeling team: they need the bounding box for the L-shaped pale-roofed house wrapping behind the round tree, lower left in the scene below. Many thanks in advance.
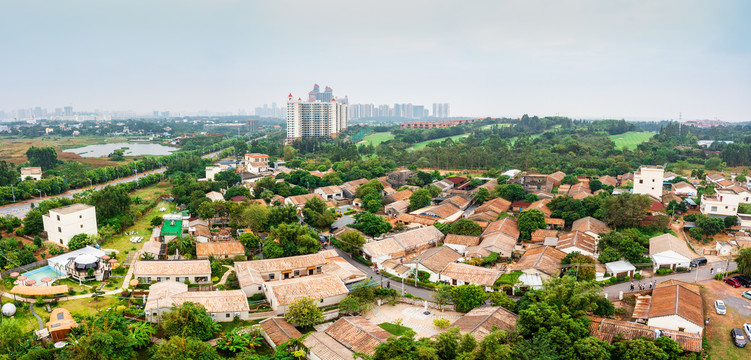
[144,281,250,323]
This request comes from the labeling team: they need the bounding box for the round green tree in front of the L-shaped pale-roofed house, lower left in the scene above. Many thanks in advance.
[161,302,216,341]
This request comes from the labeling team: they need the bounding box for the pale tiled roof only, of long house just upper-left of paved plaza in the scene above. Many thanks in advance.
[265,274,349,305]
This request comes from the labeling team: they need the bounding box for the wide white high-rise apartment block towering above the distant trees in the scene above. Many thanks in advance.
[287,94,347,141]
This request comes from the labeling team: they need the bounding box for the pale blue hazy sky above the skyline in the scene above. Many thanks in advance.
[0,0,751,121]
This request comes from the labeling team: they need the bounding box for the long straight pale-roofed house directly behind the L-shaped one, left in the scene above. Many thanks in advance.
[133,260,211,284]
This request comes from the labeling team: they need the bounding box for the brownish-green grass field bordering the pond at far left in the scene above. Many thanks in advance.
[0,136,123,164]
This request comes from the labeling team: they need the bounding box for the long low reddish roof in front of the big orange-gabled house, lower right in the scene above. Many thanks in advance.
[589,317,702,352]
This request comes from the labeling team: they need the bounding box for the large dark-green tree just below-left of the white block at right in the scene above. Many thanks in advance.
[602,193,653,228]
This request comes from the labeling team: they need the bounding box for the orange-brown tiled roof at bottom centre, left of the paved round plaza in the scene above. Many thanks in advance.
[325,316,391,355]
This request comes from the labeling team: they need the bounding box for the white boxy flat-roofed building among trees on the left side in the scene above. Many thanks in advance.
[42,204,97,247]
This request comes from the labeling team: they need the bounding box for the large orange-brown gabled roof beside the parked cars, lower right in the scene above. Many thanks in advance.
[649,281,704,327]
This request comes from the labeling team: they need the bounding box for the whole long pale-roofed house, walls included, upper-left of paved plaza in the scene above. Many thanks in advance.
[262,274,349,315]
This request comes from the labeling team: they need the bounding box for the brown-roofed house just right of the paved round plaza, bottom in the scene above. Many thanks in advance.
[451,306,519,342]
